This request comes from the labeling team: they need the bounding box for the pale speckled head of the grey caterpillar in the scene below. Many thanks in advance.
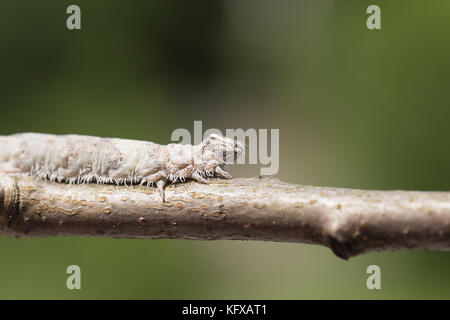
[201,133,244,165]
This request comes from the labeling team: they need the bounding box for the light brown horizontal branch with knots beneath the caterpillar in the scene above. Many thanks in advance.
[0,176,450,259]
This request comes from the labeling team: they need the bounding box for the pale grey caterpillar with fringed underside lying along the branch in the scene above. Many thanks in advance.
[0,133,243,201]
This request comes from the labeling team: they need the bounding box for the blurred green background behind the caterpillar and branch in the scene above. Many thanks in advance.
[0,0,450,299]
